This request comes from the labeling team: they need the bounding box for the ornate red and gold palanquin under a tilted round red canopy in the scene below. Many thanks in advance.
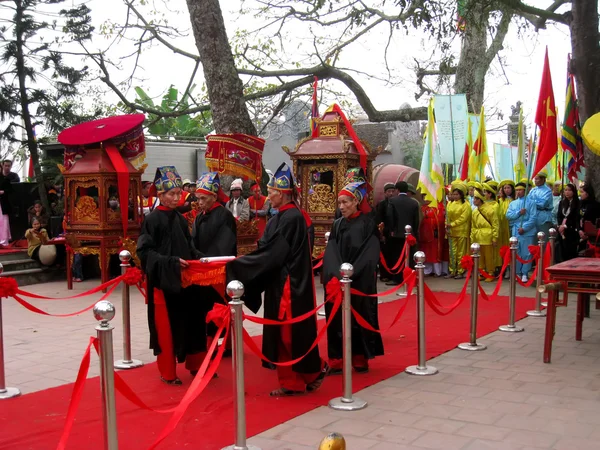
[58,114,145,289]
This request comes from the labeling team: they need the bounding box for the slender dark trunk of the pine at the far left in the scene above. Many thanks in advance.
[15,1,51,213]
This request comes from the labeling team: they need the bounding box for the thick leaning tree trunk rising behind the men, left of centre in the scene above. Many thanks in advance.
[187,0,256,135]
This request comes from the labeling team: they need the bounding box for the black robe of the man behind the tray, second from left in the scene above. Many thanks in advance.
[192,204,237,336]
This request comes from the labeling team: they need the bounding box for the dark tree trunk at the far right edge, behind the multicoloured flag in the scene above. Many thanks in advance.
[570,0,600,193]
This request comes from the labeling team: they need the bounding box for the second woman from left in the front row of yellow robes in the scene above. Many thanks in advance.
[471,183,499,281]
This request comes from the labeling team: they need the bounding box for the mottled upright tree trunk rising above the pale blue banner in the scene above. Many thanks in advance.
[454,2,489,114]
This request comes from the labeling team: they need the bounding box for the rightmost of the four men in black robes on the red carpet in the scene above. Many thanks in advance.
[323,182,383,374]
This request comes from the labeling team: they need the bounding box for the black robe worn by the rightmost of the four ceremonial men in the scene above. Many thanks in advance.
[323,213,383,359]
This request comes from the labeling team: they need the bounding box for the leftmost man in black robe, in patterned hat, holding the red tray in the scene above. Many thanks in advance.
[137,166,206,385]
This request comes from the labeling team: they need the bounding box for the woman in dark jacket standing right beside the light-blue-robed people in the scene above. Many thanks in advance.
[557,183,581,262]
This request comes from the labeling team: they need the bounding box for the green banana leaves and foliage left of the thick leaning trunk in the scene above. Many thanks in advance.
[119,85,212,139]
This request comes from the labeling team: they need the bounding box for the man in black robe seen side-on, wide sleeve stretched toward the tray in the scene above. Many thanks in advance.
[226,164,329,396]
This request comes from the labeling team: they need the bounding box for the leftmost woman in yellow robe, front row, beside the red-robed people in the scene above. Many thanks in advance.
[446,183,471,279]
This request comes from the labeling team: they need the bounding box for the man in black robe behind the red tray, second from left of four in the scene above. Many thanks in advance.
[192,172,237,356]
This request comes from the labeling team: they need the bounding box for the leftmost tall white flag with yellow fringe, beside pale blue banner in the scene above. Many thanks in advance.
[417,99,444,208]
